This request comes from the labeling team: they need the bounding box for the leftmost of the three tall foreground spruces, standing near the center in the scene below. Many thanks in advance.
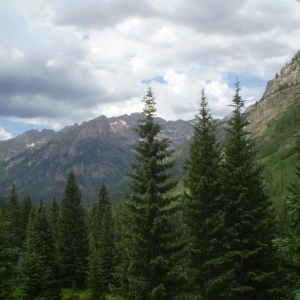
[117,88,180,300]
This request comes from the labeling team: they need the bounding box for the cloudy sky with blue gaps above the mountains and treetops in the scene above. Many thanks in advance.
[0,0,300,140]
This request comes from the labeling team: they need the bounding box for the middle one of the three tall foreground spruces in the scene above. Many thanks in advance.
[184,91,224,299]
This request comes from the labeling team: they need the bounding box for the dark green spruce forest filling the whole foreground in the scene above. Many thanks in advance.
[0,81,300,300]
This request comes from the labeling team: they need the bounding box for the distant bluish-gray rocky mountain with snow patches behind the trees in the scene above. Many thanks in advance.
[0,113,193,201]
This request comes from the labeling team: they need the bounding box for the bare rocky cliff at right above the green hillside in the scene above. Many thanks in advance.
[245,51,300,136]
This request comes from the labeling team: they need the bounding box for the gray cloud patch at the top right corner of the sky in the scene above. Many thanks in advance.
[169,0,299,36]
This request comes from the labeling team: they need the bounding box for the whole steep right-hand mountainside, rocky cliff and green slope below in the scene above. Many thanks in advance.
[245,51,300,210]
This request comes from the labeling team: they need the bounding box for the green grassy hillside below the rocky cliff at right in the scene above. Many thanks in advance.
[257,98,300,210]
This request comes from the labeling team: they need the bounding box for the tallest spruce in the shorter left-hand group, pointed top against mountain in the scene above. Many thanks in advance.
[58,171,89,288]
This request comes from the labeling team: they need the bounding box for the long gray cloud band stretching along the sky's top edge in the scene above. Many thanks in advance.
[50,0,299,35]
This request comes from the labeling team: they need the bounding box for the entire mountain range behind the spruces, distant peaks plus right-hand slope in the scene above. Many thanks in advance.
[0,51,300,207]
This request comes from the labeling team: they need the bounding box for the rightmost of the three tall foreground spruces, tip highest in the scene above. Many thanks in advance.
[219,82,277,300]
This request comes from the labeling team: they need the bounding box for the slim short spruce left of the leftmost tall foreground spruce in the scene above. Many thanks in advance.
[91,183,115,292]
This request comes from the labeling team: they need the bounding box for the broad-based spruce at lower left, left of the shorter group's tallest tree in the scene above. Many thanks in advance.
[18,201,61,300]
